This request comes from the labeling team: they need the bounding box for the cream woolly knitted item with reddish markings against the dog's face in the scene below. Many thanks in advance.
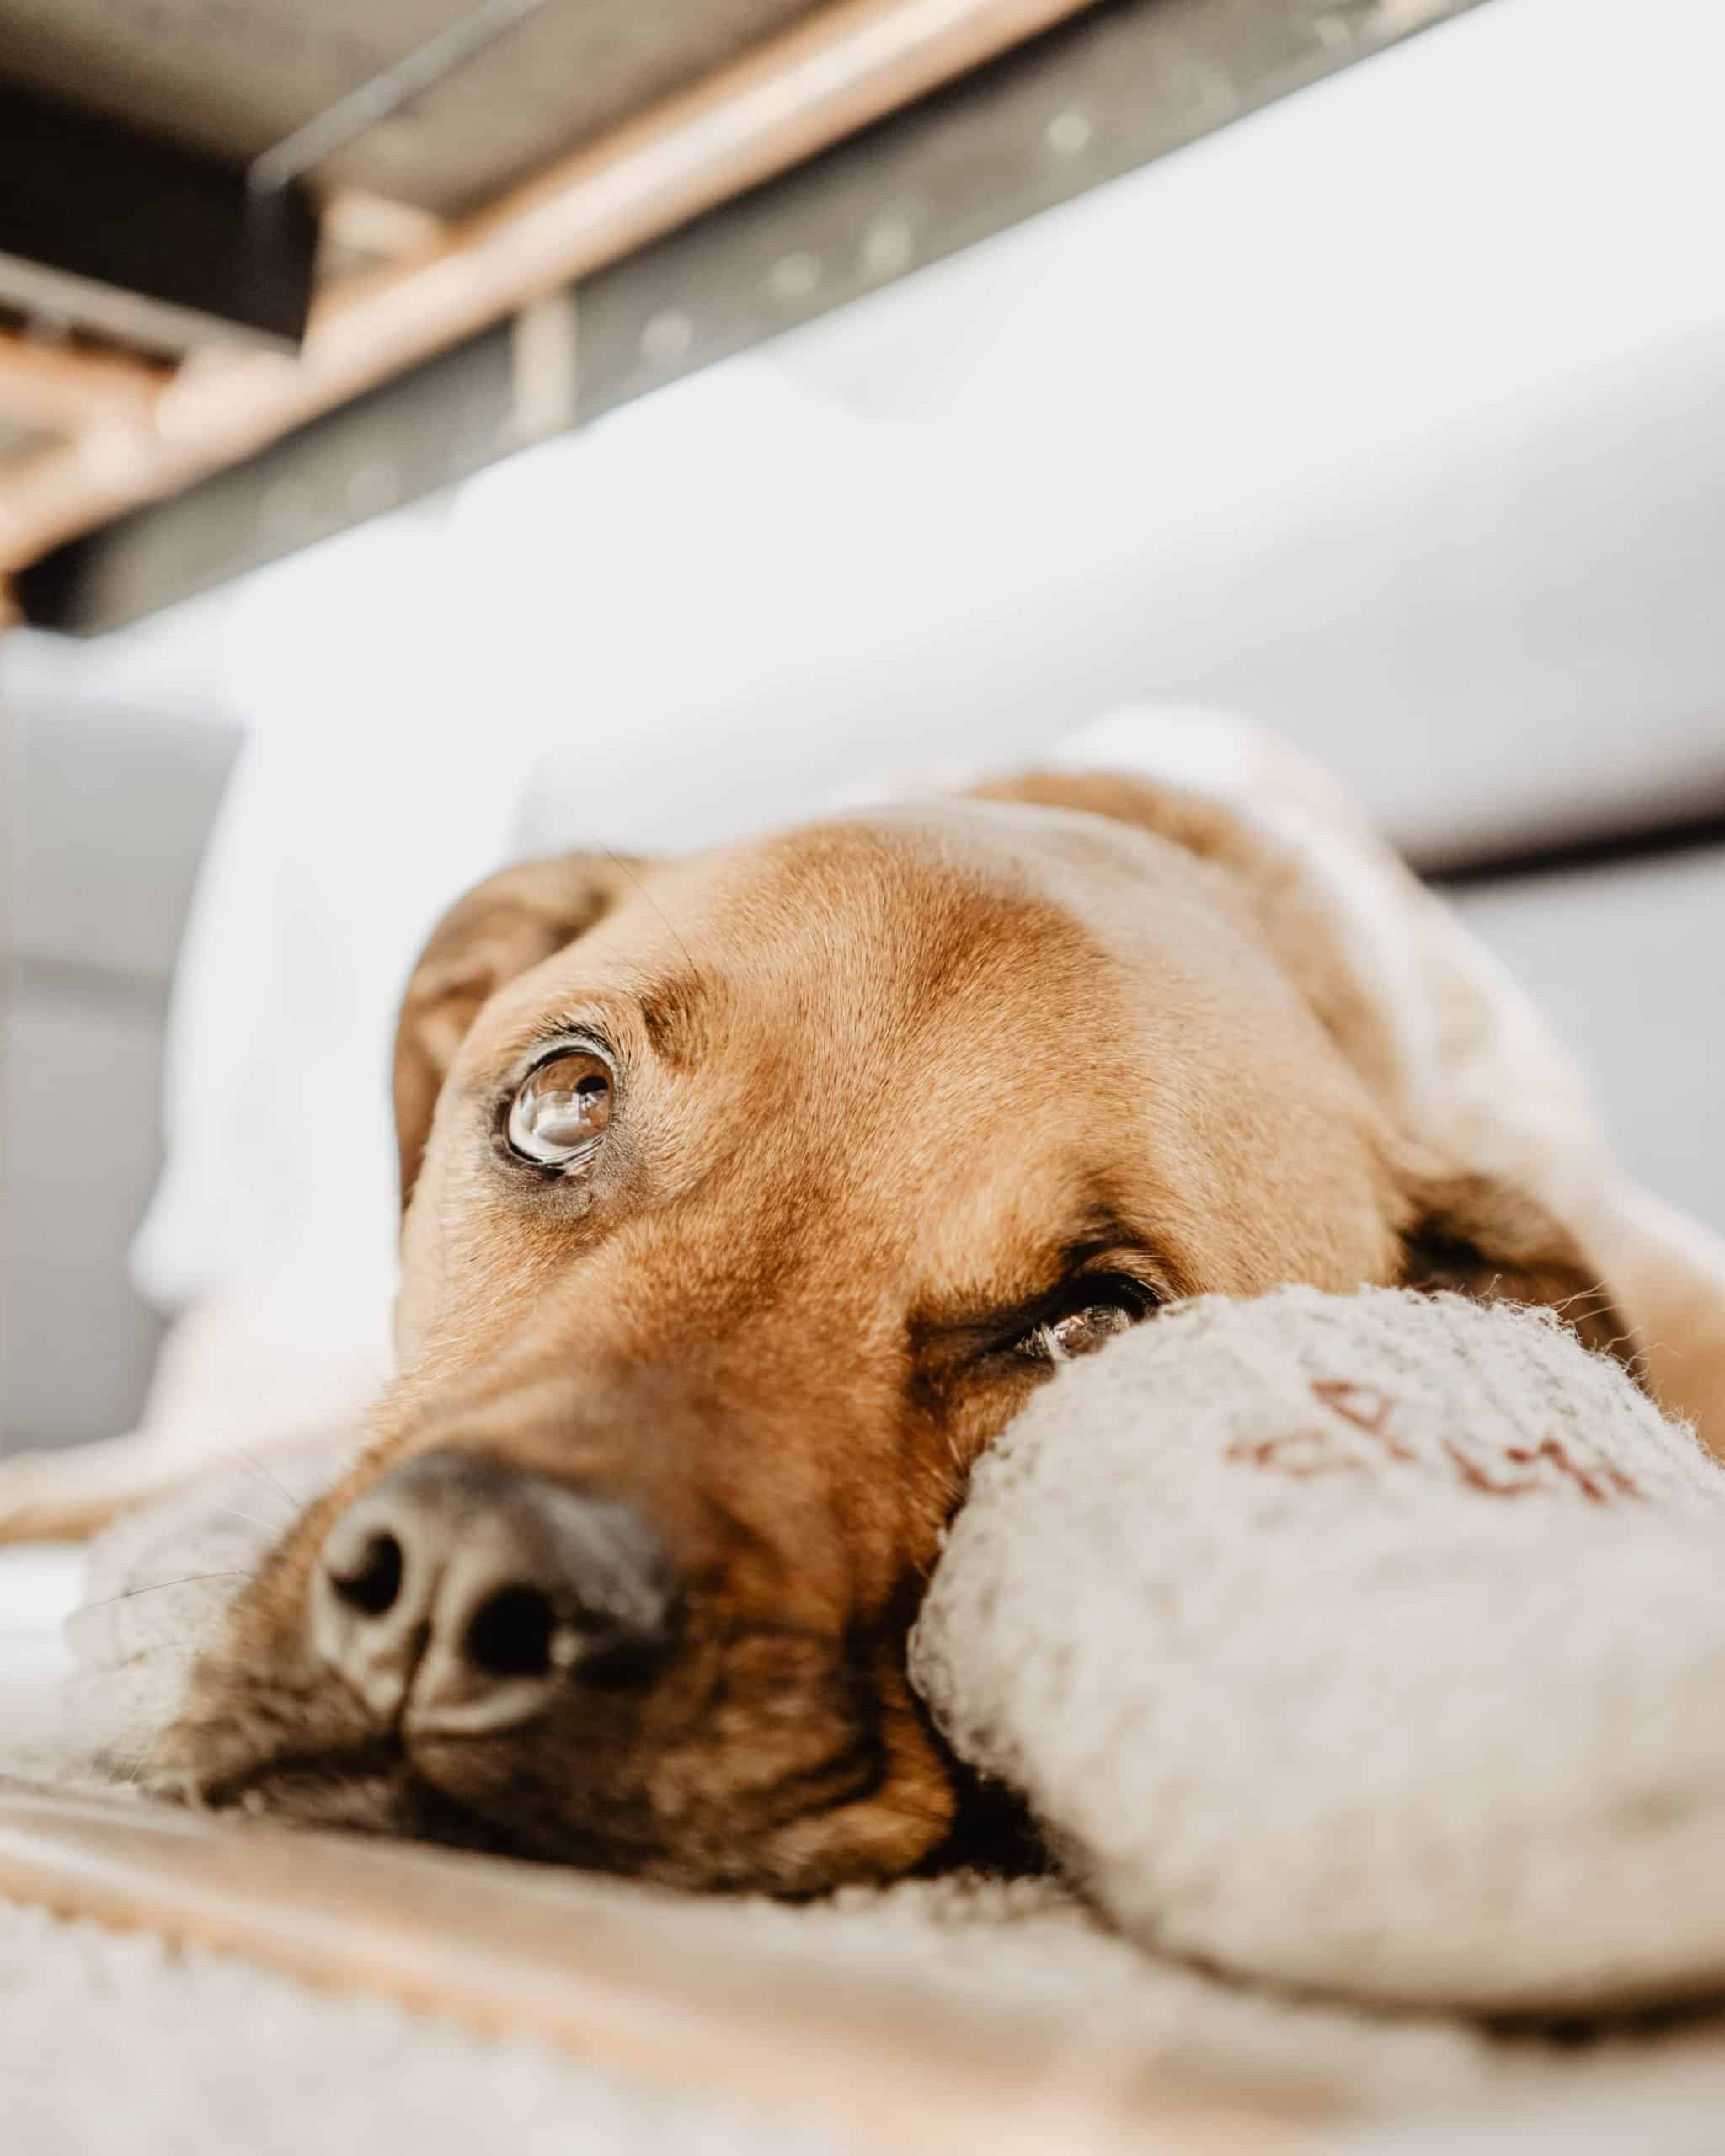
[912,1287,1725,2011]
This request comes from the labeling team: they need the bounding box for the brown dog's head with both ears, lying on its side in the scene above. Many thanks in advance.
[168,781,1621,1891]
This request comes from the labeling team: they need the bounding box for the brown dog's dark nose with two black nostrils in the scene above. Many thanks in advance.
[311,1449,677,1736]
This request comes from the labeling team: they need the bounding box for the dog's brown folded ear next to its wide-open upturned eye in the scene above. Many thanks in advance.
[394,854,638,1205]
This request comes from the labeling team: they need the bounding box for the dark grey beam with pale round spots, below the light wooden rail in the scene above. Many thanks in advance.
[19,0,1479,634]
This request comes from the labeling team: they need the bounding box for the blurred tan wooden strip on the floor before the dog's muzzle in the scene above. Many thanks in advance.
[0,1781,1320,2156]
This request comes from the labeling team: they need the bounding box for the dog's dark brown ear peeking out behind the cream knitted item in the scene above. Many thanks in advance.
[1402,1175,1637,1369]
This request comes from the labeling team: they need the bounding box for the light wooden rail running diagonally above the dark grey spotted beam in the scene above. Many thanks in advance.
[0,0,1089,574]
